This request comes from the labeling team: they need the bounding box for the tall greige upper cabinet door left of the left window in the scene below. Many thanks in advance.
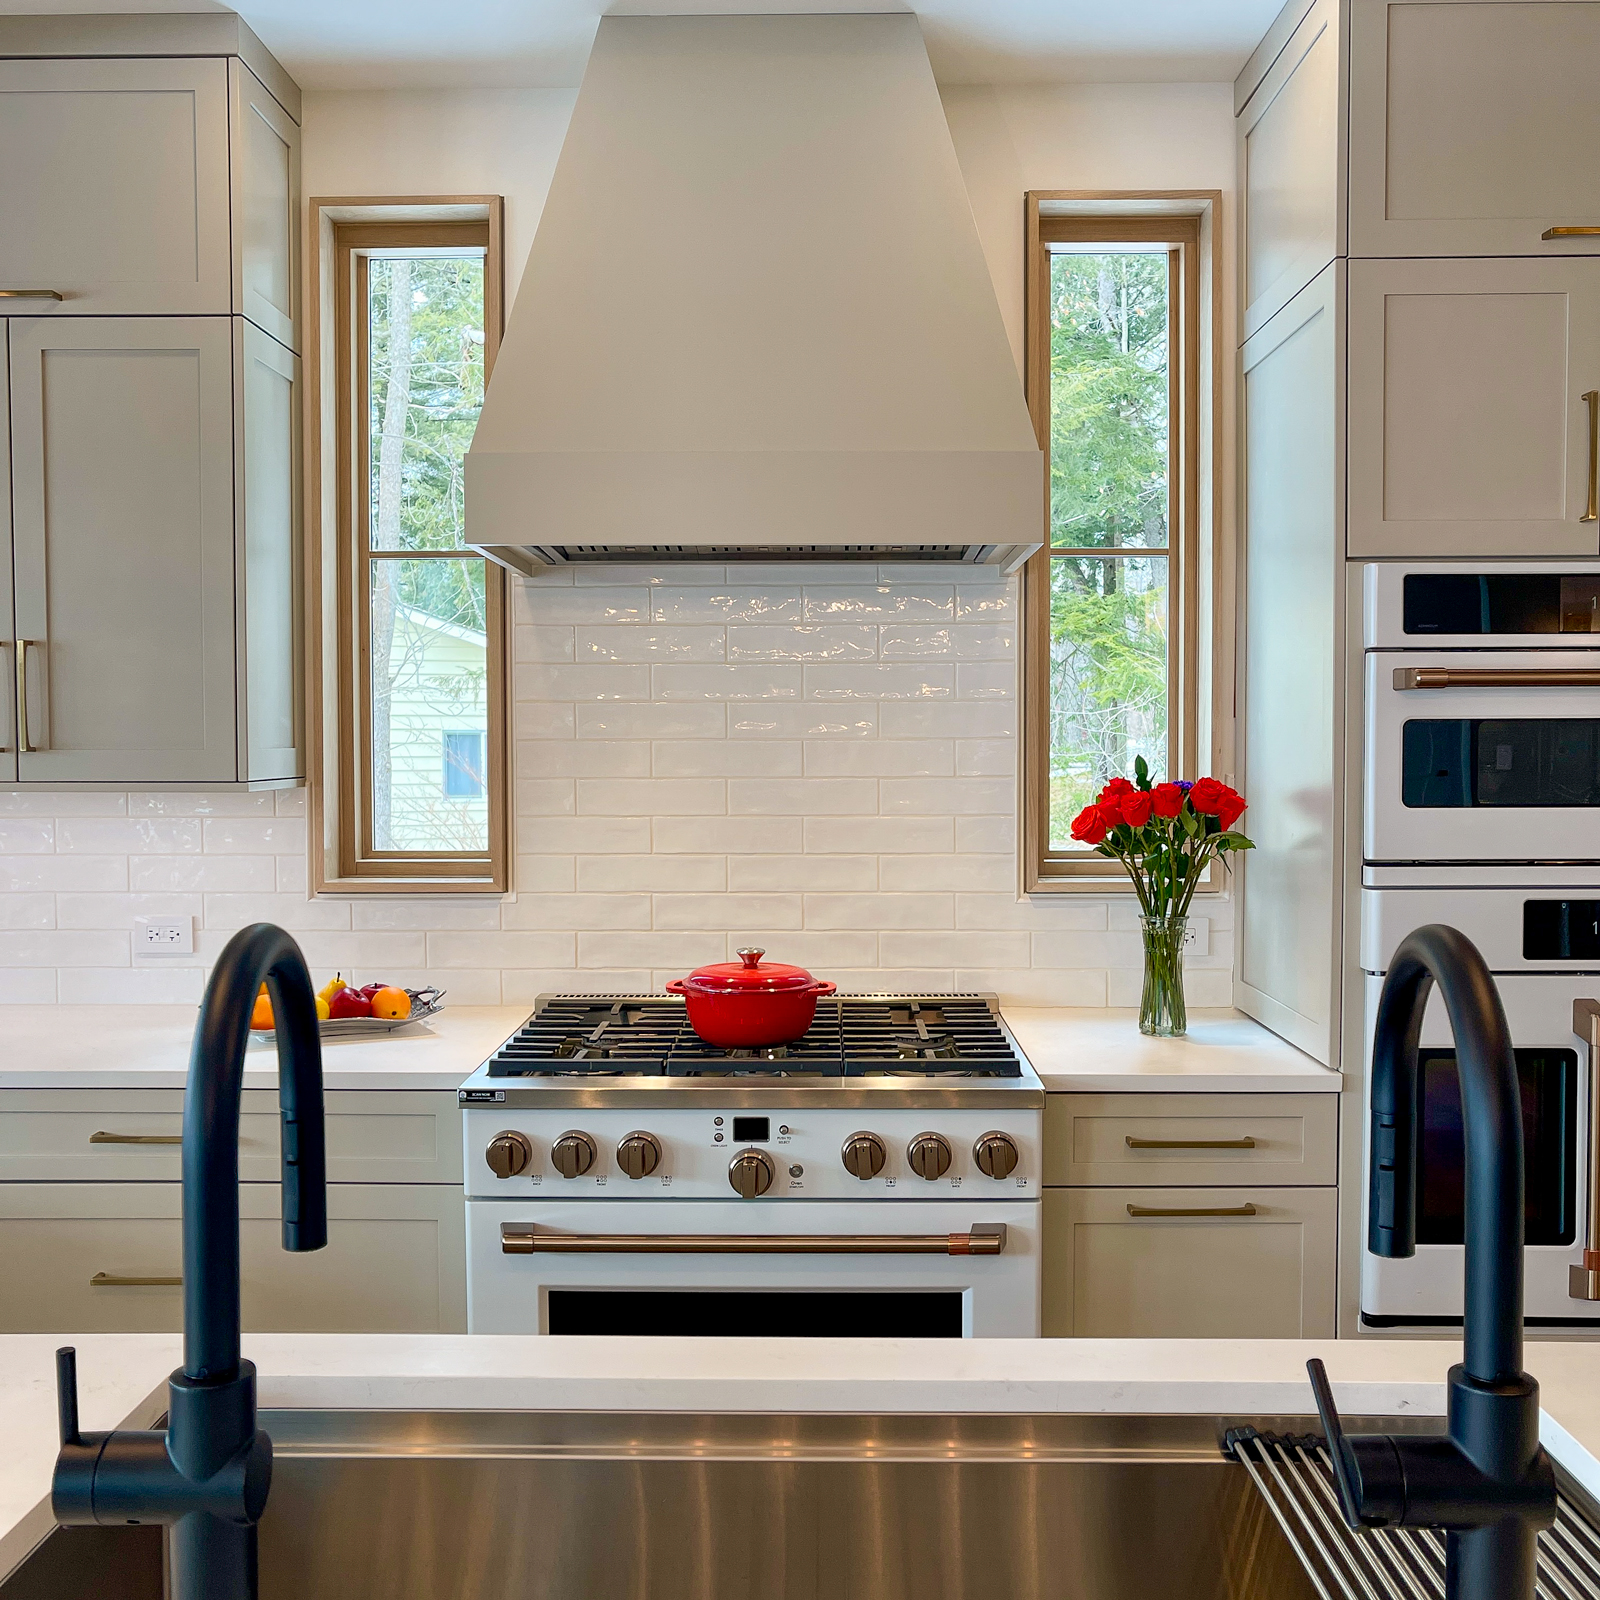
[11,317,238,782]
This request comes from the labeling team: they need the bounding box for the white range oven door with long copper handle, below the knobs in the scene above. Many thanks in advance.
[467,1200,1040,1339]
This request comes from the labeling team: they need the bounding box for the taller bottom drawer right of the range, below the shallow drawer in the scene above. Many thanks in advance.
[1043,1189,1338,1339]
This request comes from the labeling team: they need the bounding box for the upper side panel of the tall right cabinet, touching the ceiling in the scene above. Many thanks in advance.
[1238,0,1344,339]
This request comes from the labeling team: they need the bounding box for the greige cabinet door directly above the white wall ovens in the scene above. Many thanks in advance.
[1347,258,1600,558]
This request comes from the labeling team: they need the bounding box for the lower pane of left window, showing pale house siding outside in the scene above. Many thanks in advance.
[371,557,490,851]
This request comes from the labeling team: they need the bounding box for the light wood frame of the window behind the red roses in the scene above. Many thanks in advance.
[1019,190,1232,894]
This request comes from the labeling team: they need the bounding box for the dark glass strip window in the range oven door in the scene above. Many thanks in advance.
[549,1290,962,1339]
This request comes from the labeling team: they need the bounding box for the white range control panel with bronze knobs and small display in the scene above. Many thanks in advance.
[462,1102,1040,1200]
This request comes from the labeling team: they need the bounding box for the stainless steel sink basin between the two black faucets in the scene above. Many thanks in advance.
[0,1411,1437,1600]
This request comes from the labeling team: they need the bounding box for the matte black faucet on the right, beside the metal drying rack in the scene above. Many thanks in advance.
[1307,925,1555,1600]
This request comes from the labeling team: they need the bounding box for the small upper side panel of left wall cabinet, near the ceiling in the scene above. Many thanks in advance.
[227,58,299,352]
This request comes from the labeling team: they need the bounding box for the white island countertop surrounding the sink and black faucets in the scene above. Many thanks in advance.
[0,1334,1600,1578]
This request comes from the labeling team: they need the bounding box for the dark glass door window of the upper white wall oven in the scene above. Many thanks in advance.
[1400,717,1600,810]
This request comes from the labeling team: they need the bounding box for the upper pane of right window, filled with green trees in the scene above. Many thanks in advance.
[1050,248,1168,549]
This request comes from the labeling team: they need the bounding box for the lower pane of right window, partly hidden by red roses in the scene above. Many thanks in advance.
[1050,555,1166,850]
